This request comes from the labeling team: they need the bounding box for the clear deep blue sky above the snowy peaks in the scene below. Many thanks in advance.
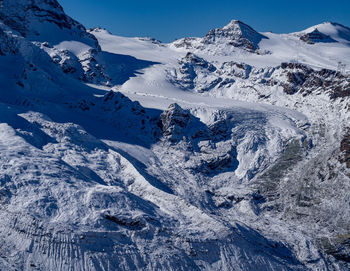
[58,0,350,42]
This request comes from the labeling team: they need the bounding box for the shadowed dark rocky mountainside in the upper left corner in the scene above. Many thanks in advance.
[0,0,106,84]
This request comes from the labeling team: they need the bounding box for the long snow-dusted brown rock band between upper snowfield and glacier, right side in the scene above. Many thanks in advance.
[168,58,350,99]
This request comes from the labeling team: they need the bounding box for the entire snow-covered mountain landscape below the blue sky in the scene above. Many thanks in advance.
[0,0,350,271]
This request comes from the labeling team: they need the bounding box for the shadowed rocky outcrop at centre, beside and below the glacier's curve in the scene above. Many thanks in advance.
[159,104,267,179]
